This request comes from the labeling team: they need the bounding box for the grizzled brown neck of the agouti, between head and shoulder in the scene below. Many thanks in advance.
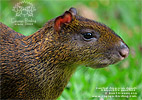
[18,21,76,99]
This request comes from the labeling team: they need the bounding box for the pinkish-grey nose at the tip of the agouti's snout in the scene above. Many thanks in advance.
[119,43,129,59]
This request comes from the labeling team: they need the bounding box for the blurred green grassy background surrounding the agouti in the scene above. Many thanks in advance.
[0,0,142,100]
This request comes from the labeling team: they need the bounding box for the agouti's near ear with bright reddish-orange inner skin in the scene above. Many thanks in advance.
[54,11,73,32]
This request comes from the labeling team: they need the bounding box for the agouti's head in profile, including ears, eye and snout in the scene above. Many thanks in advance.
[54,8,129,68]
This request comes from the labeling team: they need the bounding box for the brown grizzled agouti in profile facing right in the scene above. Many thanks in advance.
[0,8,129,100]
